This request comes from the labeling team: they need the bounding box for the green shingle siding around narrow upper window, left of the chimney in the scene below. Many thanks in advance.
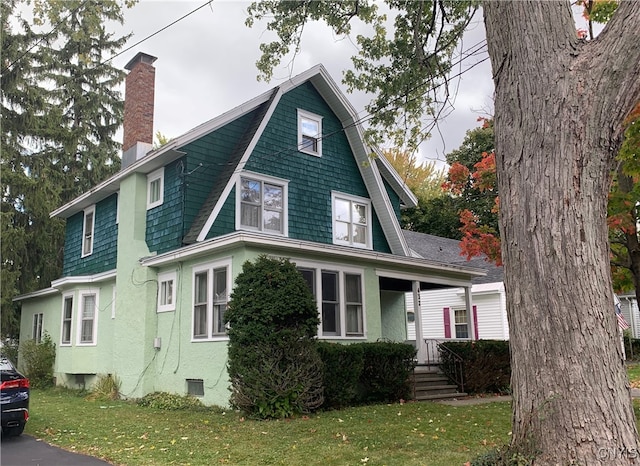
[62,194,118,277]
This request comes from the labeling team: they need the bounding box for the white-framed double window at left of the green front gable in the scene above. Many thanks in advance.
[236,175,287,235]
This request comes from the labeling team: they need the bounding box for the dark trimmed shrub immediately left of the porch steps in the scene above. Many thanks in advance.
[360,342,416,403]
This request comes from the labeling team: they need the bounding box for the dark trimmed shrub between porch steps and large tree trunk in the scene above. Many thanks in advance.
[440,340,511,393]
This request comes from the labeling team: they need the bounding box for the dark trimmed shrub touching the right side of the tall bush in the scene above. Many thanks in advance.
[318,342,364,408]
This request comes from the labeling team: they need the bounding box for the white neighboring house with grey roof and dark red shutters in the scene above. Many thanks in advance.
[403,230,509,358]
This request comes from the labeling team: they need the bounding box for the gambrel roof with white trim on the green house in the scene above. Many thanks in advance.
[51,65,417,256]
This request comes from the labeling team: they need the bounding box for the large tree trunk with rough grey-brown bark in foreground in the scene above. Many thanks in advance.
[484,1,640,465]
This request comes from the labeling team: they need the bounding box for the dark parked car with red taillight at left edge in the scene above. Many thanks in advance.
[0,356,29,436]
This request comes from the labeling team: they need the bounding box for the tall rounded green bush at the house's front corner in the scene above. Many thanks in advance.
[225,255,323,418]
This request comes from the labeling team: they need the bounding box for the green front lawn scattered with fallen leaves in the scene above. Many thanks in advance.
[26,389,511,466]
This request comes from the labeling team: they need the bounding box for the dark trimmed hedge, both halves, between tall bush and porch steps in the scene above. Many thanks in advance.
[318,342,416,408]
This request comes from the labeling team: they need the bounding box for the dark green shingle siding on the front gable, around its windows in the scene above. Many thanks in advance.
[245,83,390,252]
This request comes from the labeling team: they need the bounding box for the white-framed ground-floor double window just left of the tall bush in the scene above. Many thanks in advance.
[192,260,231,340]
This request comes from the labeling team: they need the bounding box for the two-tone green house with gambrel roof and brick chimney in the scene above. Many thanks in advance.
[16,53,485,406]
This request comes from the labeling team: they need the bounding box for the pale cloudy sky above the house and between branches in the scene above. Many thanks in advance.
[112,0,493,168]
